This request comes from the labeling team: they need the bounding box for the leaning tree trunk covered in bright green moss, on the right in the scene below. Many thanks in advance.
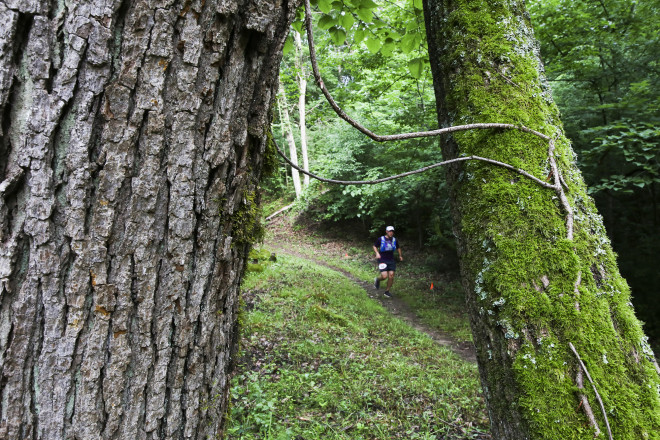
[424,0,660,440]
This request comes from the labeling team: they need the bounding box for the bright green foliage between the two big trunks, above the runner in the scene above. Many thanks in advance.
[275,2,449,242]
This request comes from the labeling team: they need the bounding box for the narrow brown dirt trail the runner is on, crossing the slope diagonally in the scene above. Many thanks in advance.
[265,234,477,362]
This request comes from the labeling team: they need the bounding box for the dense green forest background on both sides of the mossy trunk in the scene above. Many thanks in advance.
[264,0,660,352]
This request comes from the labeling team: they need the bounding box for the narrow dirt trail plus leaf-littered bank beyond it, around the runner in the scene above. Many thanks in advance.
[264,217,476,362]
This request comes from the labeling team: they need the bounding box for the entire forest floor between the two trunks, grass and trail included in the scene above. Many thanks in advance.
[227,212,490,440]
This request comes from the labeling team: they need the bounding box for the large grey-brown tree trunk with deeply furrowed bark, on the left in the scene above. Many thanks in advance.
[0,0,295,440]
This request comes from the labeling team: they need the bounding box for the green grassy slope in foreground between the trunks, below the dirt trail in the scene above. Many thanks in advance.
[227,255,490,440]
